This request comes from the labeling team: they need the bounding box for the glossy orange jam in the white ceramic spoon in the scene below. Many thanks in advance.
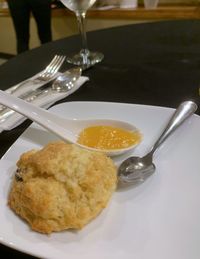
[77,126,141,150]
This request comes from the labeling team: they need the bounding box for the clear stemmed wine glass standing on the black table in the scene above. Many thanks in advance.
[60,0,104,67]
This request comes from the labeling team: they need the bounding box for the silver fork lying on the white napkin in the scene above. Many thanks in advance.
[9,55,66,94]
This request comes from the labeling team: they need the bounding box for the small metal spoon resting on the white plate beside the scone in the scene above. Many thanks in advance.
[118,101,197,184]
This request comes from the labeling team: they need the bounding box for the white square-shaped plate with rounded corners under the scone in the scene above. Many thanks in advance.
[0,102,200,259]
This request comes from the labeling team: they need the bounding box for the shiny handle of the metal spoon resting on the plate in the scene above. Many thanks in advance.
[150,101,197,155]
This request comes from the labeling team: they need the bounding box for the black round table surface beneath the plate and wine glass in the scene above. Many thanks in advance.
[0,20,200,258]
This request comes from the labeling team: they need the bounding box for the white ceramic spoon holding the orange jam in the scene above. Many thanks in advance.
[0,91,141,156]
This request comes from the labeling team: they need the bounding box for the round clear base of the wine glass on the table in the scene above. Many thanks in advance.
[67,52,104,67]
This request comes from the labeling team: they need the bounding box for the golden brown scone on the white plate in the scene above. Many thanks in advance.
[8,142,117,234]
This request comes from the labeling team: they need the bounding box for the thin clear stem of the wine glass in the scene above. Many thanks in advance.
[76,12,89,58]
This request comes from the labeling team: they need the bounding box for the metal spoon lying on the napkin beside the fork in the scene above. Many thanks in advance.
[0,67,82,122]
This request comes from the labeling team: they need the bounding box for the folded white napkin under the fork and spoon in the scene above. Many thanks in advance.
[0,76,89,133]
